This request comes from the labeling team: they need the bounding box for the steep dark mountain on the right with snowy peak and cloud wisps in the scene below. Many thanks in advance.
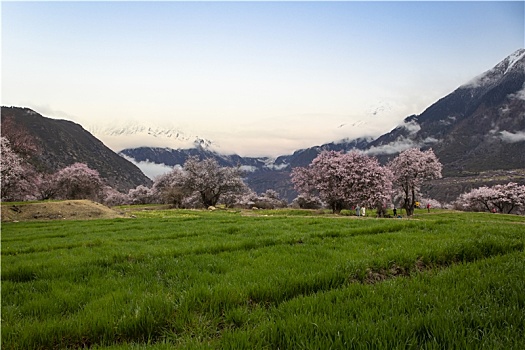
[366,49,525,176]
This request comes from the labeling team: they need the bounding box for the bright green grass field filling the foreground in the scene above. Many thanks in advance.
[1,208,525,349]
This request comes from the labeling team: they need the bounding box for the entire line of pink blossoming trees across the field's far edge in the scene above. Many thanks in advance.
[0,136,525,216]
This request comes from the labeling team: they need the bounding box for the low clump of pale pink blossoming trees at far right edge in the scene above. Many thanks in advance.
[455,182,525,214]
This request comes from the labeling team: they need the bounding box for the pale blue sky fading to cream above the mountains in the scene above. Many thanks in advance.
[1,1,525,155]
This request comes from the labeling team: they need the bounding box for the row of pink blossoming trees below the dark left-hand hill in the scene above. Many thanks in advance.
[0,137,248,208]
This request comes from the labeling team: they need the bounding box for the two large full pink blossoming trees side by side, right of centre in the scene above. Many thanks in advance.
[292,148,442,215]
